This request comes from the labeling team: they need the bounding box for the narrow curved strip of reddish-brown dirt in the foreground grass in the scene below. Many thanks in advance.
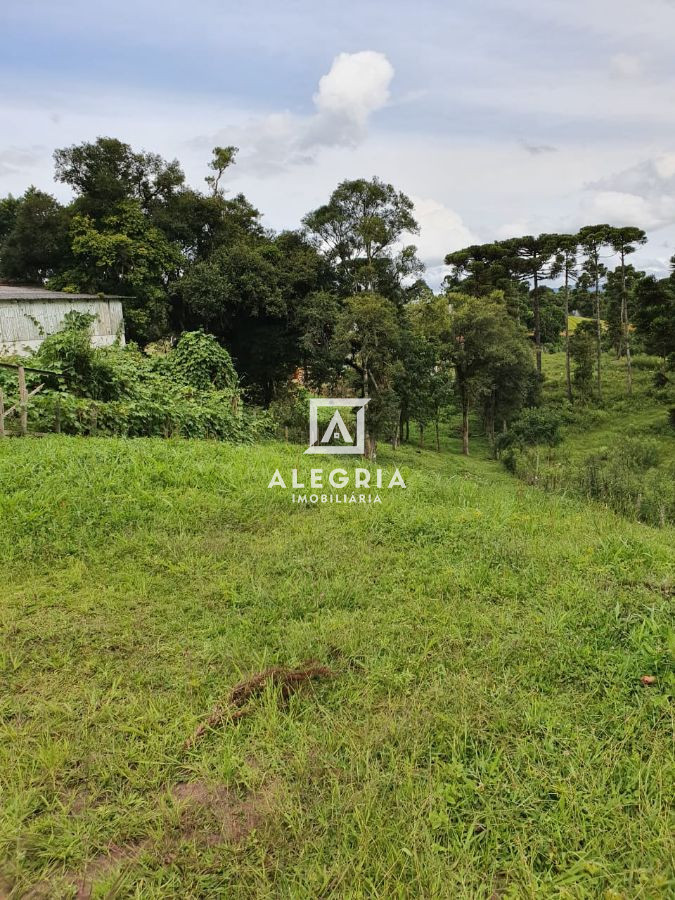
[185,662,335,750]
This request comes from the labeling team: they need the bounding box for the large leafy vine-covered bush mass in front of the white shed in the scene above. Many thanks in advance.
[21,314,273,442]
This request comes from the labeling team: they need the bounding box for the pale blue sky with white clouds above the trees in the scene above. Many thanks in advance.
[0,0,675,286]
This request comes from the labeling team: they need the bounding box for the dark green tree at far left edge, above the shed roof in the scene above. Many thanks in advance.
[0,187,68,284]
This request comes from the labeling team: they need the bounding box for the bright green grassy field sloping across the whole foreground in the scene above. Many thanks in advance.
[0,437,675,898]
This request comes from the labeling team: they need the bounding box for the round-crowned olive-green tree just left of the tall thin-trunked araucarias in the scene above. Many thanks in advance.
[451,295,533,456]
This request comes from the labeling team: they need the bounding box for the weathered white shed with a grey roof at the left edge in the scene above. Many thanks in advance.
[0,284,124,356]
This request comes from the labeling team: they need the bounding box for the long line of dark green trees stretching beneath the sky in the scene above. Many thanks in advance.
[0,138,675,453]
